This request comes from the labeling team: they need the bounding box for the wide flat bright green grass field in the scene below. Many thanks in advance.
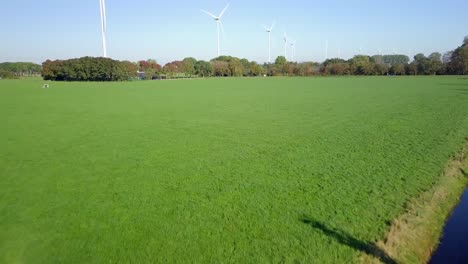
[0,77,468,263]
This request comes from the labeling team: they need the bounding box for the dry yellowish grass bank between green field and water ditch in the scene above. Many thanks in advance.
[360,138,468,263]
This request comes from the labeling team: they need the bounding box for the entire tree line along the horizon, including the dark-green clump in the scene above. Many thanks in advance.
[0,37,468,81]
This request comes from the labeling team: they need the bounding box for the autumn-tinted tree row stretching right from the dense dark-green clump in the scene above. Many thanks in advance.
[128,37,468,79]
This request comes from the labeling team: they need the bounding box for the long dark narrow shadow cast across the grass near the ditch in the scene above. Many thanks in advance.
[300,217,398,264]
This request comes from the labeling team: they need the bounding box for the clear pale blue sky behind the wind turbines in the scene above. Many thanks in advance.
[0,0,468,63]
